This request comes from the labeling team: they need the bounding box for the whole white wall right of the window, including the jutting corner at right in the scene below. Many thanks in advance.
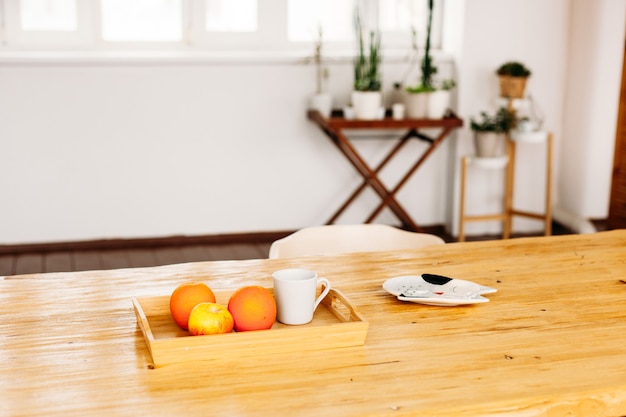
[448,0,626,234]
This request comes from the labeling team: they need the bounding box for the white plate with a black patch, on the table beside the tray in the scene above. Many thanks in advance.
[383,274,498,306]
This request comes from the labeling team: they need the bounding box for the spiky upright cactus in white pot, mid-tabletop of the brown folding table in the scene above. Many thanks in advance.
[352,14,382,120]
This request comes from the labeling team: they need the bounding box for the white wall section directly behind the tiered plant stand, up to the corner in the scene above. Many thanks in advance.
[450,0,569,235]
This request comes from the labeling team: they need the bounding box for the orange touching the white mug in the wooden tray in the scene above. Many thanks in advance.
[228,285,276,332]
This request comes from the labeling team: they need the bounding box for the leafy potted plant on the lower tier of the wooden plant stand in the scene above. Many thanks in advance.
[470,107,515,158]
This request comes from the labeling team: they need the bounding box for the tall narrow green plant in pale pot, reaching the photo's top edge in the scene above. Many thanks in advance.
[406,0,437,119]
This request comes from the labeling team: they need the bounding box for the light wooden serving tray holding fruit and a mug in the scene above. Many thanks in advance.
[133,289,369,366]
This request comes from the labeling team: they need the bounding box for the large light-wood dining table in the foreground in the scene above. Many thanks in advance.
[0,230,626,417]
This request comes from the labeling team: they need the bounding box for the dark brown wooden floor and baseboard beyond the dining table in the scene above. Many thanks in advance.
[0,224,600,276]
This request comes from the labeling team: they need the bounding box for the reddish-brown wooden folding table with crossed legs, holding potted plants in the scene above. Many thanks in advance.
[308,110,463,232]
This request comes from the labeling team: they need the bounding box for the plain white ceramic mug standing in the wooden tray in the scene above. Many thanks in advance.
[272,268,330,324]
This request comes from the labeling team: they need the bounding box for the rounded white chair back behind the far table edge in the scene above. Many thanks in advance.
[269,224,445,259]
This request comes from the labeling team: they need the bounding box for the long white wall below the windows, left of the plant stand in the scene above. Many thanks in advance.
[0,60,445,243]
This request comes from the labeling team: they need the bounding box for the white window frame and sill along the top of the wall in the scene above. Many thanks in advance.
[0,0,445,57]
